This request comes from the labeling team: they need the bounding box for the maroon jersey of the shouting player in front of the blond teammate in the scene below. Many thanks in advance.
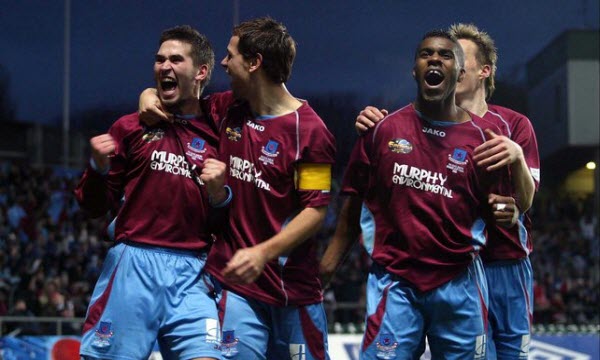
[342,105,504,291]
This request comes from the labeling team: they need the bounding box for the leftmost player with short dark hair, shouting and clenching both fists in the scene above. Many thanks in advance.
[75,26,231,359]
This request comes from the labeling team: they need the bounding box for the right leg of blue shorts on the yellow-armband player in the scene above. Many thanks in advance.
[267,303,329,360]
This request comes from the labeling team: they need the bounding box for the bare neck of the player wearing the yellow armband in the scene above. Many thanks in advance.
[248,83,302,116]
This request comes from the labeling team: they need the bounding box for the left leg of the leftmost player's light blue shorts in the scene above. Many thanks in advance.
[80,244,160,359]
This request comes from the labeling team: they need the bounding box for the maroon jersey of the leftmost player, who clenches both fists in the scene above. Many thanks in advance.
[75,100,218,250]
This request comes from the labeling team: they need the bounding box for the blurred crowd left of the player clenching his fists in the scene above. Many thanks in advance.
[0,163,110,334]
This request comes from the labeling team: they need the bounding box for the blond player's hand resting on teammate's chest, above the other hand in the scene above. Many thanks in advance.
[473,129,523,171]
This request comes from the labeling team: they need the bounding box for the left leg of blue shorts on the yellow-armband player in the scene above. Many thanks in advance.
[219,290,270,360]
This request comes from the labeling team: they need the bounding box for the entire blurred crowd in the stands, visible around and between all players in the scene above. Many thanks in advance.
[0,163,600,334]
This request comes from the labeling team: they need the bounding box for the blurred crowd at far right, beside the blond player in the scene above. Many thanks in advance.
[531,198,600,324]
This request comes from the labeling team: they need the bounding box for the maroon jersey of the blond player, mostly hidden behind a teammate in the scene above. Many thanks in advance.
[481,105,540,262]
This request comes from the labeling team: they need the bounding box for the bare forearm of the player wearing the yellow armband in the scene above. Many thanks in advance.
[257,206,327,261]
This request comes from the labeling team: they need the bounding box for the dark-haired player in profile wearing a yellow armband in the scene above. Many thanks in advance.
[140,17,335,359]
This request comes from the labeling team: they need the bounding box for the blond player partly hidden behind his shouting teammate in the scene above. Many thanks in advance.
[356,24,540,359]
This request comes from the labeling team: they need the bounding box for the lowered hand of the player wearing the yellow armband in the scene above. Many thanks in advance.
[222,246,267,284]
